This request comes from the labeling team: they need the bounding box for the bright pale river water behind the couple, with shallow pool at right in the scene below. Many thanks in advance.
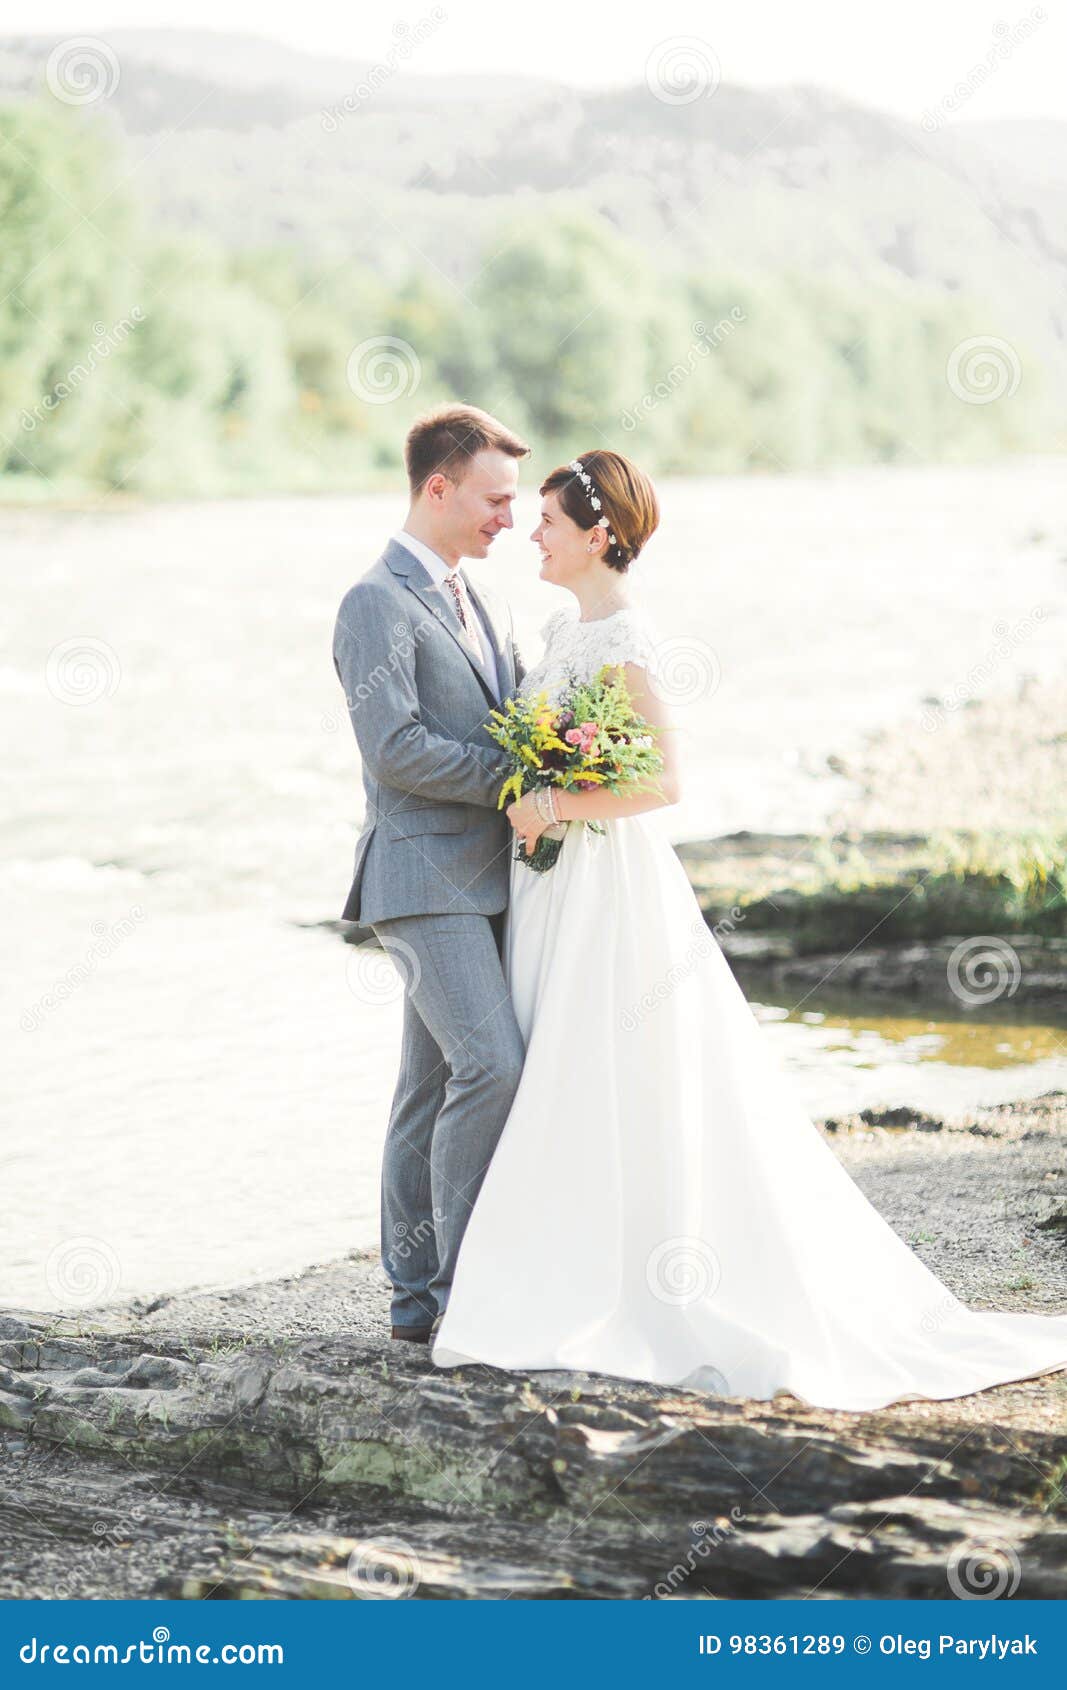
[0,460,1067,1308]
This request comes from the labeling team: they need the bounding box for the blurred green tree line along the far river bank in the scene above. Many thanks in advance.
[0,101,1057,499]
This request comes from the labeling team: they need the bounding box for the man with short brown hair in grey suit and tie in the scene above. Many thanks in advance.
[333,406,529,1344]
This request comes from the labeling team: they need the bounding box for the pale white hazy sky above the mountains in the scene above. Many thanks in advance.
[8,0,1067,122]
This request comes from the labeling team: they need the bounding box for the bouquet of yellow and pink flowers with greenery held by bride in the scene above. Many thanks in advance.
[485,664,663,874]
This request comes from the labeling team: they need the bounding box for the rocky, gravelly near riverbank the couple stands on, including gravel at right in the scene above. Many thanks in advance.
[0,1093,1067,1599]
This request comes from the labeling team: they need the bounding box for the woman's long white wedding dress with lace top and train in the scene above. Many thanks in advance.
[431,608,1067,1409]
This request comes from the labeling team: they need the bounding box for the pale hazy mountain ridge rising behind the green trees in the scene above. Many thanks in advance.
[0,31,1067,387]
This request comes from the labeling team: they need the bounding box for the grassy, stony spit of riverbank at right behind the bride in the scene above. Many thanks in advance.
[678,678,1067,993]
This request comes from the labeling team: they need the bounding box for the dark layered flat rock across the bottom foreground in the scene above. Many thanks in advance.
[0,1317,1067,1599]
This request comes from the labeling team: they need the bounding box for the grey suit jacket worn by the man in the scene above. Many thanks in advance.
[333,539,524,926]
